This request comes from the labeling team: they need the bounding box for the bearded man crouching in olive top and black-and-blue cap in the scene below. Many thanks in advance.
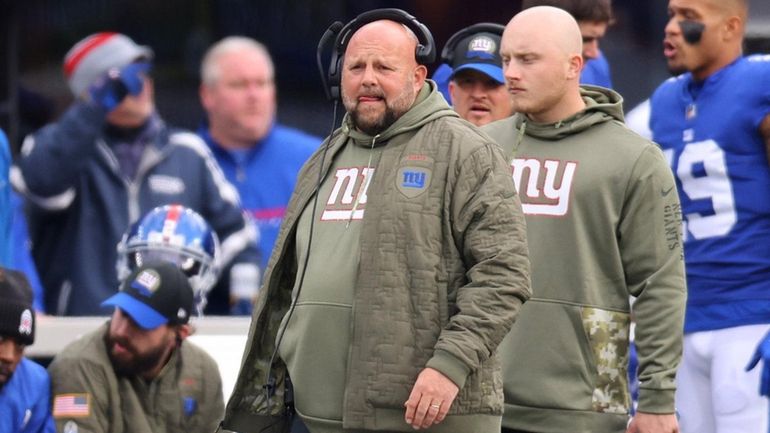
[49,262,224,433]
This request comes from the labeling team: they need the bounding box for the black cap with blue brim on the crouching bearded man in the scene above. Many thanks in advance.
[102,262,193,330]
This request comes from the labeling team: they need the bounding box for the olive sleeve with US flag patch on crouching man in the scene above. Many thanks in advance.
[48,358,111,433]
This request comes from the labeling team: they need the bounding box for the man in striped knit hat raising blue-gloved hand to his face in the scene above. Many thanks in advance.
[11,33,259,316]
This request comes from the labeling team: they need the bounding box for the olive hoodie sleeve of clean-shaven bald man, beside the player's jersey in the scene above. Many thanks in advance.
[619,144,686,413]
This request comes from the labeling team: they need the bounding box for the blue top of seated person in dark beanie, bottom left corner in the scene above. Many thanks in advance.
[0,358,56,433]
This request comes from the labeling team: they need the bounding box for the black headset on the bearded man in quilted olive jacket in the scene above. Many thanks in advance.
[317,8,436,101]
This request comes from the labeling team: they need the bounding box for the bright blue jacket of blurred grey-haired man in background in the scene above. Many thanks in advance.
[198,124,322,269]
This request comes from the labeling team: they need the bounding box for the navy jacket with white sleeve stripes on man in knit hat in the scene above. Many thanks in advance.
[11,103,259,316]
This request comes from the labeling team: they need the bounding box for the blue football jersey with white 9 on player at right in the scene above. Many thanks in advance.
[650,56,770,332]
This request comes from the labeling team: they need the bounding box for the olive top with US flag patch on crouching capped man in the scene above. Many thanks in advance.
[48,322,224,433]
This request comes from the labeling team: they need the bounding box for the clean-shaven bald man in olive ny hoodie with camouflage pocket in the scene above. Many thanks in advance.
[484,7,686,433]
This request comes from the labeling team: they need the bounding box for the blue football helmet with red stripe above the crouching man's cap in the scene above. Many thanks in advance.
[117,204,219,315]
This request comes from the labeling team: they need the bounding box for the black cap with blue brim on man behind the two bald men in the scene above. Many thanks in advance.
[450,32,505,84]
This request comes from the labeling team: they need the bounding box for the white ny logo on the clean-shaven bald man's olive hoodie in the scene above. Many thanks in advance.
[511,158,577,216]
